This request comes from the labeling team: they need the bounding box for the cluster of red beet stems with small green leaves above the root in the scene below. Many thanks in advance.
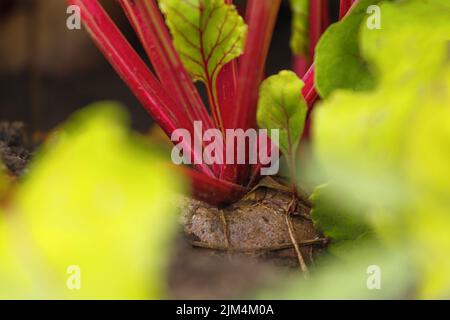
[68,0,352,204]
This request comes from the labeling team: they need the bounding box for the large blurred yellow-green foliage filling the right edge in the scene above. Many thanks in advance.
[314,0,450,298]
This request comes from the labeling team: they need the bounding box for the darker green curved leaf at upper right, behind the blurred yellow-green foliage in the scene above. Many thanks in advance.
[315,0,379,98]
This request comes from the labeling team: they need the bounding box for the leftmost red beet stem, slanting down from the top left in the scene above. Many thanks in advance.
[67,0,214,176]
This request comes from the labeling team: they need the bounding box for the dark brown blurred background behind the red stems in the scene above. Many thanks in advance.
[0,0,339,133]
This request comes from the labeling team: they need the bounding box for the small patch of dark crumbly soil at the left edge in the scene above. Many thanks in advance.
[0,122,33,176]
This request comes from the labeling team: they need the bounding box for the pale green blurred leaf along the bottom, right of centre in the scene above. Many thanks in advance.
[257,245,417,300]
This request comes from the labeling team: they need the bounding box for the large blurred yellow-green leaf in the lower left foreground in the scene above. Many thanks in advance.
[0,104,180,299]
